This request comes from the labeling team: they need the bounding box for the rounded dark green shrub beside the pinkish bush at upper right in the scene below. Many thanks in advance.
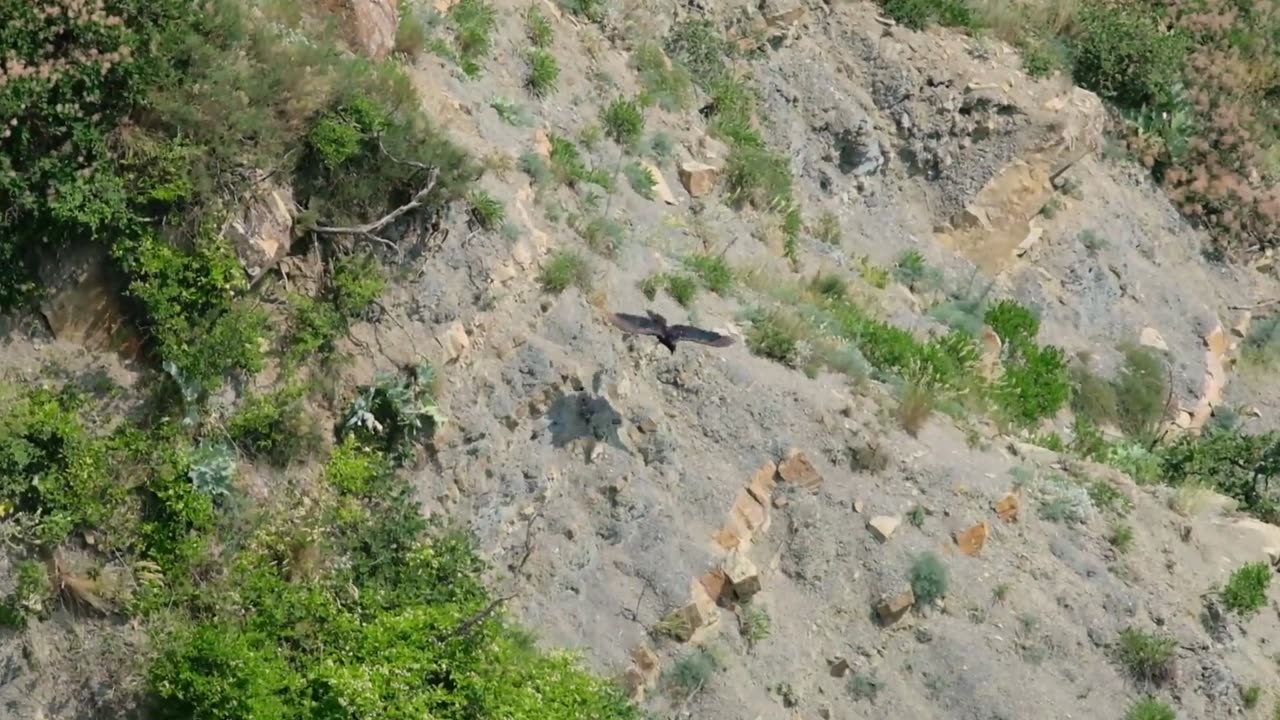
[1071,4,1189,109]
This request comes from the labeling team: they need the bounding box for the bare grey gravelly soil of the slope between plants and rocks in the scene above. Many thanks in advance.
[0,0,1280,720]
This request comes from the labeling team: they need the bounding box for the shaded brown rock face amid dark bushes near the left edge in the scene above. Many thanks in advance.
[40,245,141,357]
